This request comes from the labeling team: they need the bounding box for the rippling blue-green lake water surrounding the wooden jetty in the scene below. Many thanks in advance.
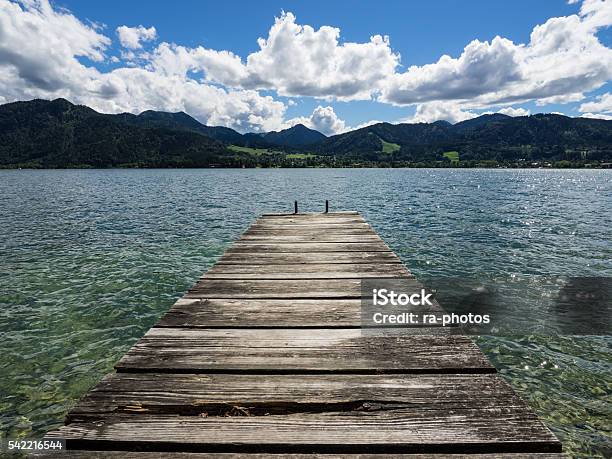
[0,169,612,457]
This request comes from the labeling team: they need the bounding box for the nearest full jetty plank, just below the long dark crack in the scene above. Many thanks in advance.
[54,407,561,453]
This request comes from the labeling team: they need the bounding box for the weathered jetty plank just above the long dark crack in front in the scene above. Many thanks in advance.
[69,373,540,420]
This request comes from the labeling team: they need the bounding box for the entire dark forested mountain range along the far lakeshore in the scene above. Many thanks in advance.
[0,99,612,168]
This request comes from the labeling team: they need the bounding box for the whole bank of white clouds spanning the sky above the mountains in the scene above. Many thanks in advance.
[0,0,612,134]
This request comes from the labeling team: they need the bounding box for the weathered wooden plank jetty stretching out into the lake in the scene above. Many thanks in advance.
[49,212,561,458]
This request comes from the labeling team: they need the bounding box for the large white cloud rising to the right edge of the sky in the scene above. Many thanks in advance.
[380,0,612,108]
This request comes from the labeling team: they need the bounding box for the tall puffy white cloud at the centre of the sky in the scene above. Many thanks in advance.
[243,13,400,100]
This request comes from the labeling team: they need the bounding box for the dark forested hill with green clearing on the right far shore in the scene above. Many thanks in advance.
[316,114,612,162]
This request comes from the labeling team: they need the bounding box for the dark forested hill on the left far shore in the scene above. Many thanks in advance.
[0,99,235,167]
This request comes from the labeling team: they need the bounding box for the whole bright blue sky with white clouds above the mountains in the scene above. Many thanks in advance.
[0,0,612,134]
